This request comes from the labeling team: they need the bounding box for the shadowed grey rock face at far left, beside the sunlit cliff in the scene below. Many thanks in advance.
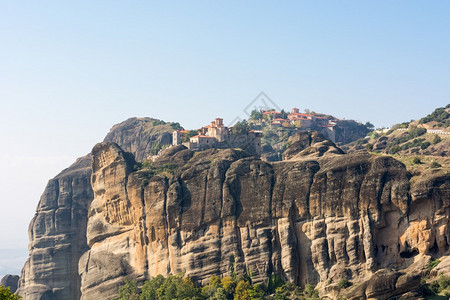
[18,155,93,299]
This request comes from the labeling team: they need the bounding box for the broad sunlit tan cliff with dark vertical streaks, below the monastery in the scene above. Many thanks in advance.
[79,135,450,299]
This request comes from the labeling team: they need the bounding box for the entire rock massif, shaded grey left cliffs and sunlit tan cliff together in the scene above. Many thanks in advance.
[18,118,450,300]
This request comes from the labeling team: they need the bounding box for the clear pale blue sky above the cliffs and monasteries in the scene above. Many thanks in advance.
[0,0,450,276]
